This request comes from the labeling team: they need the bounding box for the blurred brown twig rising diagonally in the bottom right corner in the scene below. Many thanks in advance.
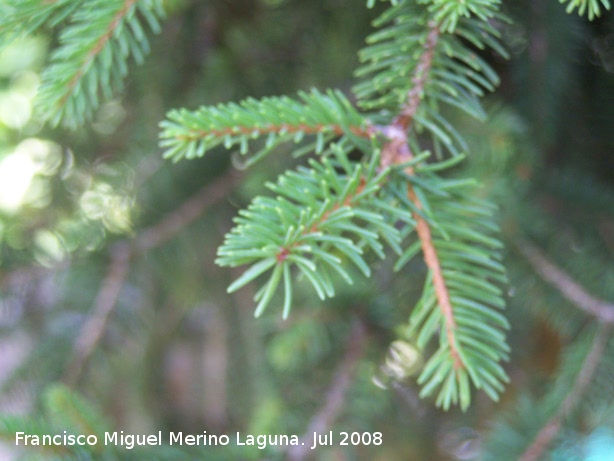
[519,324,612,461]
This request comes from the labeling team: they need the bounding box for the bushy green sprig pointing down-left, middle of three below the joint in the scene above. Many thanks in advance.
[216,146,411,318]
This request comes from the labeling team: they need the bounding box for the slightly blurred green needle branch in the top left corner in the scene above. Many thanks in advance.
[0,0,164,127]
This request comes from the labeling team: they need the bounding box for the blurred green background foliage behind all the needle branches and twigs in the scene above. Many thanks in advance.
[0,0,614,460]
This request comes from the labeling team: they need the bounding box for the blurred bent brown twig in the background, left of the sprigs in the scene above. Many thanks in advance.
[65,172,237,383]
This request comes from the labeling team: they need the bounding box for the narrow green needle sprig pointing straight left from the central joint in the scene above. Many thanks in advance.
[160,90,373,161]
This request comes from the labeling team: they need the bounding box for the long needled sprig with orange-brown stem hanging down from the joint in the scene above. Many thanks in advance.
[395,164,509,408]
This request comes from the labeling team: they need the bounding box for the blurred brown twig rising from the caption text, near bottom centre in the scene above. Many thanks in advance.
[287,320,367,461]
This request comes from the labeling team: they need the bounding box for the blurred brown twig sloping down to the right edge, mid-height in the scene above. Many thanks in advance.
[515,240,614,325]
